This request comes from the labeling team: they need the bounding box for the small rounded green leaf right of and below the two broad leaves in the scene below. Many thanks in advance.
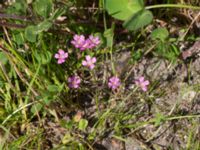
[151,28,169,41]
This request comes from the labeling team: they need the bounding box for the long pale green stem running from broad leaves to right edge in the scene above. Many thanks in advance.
[145,4,200,10]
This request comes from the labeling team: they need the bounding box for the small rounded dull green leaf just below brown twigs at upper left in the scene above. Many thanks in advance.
[25,26,37,42]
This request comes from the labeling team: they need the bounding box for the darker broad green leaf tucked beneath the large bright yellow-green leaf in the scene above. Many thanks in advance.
[123,10,153,31]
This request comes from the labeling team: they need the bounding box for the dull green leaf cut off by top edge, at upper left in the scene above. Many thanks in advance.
[33,0,53,18]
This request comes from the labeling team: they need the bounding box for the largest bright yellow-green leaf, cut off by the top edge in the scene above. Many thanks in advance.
[105,0,144,20]
